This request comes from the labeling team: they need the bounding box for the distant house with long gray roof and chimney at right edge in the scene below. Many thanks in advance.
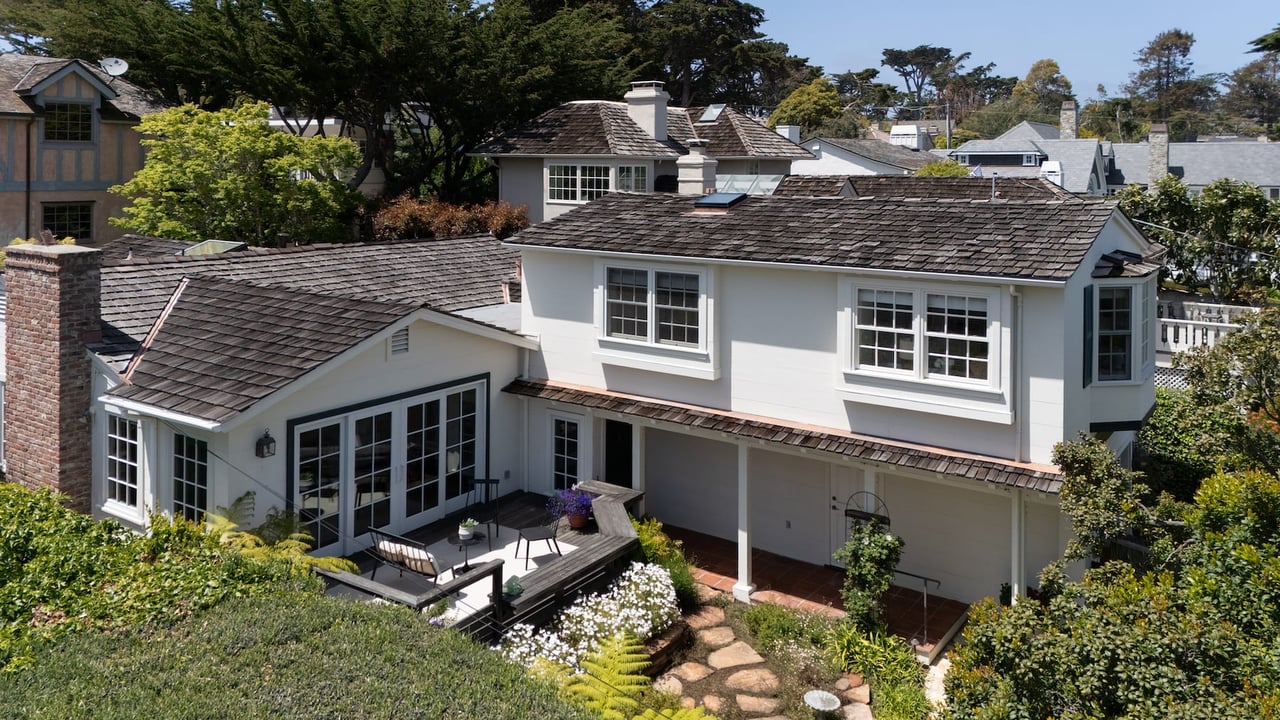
[1106,123,1280,200]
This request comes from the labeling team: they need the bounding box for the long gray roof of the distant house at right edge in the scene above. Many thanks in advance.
[1107,141,1280,187]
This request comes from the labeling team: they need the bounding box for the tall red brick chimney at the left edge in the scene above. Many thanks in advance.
[4,245,102,512]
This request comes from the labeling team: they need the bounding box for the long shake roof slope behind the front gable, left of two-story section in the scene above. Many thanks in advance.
[93,234,518,363]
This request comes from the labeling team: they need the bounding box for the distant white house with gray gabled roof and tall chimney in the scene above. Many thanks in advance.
[948,100,1107,195]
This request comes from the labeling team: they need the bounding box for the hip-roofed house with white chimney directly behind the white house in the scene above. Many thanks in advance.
[475,82,810,223]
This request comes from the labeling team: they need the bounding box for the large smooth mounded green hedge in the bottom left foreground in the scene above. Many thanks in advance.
[0,592,590,720]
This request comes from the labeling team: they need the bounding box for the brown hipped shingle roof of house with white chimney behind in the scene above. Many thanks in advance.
[474,100,812,159]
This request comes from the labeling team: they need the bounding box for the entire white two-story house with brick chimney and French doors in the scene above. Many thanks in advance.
[5,176,1157,601]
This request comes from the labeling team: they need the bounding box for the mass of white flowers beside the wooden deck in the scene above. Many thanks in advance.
[498,562,680,670]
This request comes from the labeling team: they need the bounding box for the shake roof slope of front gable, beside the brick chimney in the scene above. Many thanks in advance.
[111,275,417,421]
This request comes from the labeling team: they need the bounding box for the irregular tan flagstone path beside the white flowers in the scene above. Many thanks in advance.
[653,605,873,720]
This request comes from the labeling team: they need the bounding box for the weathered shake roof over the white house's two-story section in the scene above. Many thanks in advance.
[508,192,1119,282]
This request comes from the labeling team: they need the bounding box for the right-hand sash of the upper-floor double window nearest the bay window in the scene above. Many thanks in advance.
[924,293,991,380]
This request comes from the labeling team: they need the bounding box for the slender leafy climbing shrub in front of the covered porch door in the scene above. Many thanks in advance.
[835,521,904,630]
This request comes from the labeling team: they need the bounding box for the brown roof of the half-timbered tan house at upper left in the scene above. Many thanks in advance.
[0,53,164,120]
